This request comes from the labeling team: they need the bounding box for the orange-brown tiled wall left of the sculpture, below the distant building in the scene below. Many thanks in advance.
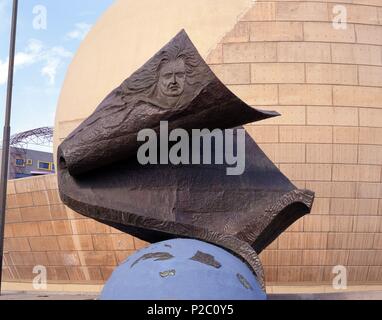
[3,175,146,284]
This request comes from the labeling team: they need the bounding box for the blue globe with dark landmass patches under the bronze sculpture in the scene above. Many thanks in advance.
[100,239,267,300]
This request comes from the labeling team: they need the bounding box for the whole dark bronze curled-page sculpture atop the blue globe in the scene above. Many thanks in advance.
[58,31,314,288]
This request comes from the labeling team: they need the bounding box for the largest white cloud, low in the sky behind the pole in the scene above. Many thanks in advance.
[0,39,73,85]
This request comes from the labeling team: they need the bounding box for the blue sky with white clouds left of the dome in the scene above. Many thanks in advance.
[0,0,114,144]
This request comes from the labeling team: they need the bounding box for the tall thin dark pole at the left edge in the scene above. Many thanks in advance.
[0,0,18,295]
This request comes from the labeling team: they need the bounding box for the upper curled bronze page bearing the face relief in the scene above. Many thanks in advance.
[58,30,279,175]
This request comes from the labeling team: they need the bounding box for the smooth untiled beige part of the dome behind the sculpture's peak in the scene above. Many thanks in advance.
[55,0,252,154]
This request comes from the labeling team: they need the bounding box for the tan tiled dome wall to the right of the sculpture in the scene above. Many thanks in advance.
[208,0,382,284]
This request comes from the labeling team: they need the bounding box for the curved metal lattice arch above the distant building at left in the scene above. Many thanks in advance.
[10,127,53,150]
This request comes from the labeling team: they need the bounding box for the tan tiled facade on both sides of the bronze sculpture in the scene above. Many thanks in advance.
[5,0,382,290]
